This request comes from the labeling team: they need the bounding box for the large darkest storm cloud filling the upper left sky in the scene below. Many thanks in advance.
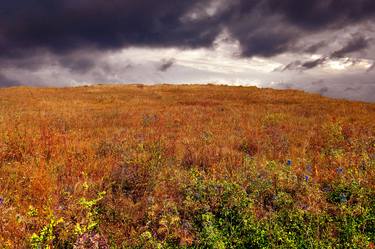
[0,0,219,56]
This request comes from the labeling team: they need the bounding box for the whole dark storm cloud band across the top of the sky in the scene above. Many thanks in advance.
[0,0,375,60]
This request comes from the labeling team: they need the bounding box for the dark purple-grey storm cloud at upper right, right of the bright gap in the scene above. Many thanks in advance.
[223,0,375,57]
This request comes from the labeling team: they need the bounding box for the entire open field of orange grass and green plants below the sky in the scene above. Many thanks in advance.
[0,85,375,248]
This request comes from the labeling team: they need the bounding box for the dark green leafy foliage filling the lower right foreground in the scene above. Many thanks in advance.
[134,171,375,248]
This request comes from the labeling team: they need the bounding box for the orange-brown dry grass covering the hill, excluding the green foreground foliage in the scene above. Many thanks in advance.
[0,85,375,248]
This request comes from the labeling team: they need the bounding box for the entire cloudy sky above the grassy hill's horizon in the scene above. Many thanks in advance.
[0,0,375,102]
